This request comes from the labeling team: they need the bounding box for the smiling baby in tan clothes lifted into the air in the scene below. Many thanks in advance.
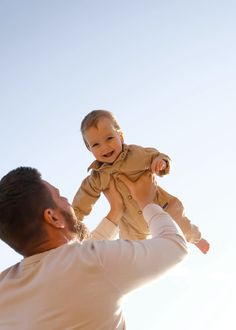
[72,110,209,254]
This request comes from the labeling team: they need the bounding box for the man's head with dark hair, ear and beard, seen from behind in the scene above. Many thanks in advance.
[0,167,88,255]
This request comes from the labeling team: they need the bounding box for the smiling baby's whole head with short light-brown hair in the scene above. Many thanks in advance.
[80,110,124,164]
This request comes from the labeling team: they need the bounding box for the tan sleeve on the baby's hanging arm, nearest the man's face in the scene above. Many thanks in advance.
[72,172,101,220]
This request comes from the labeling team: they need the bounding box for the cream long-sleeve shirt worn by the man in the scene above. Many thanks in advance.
[0,204,187,330]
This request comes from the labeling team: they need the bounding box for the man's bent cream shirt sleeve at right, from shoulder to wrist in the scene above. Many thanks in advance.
[85,204,187,296]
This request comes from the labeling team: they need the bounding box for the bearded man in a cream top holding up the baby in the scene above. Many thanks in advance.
[0,167,187,330]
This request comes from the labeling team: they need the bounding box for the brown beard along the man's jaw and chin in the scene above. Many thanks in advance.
[61,210,90,241]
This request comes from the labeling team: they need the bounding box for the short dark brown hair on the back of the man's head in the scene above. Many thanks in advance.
[0,167,55,253]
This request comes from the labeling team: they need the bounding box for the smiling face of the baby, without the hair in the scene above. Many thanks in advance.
[84,118,122,164]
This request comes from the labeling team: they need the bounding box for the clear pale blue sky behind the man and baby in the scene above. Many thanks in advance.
[0,0,236,330]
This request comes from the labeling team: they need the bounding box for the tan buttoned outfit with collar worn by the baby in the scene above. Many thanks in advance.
[72,144,199,242]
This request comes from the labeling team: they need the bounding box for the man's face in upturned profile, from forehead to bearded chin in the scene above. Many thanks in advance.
[44,181,86,239]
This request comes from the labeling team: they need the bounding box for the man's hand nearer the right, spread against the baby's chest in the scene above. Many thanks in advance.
[118,171,156,209]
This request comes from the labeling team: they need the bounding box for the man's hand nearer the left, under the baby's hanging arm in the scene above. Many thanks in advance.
[103,177,124,225]
